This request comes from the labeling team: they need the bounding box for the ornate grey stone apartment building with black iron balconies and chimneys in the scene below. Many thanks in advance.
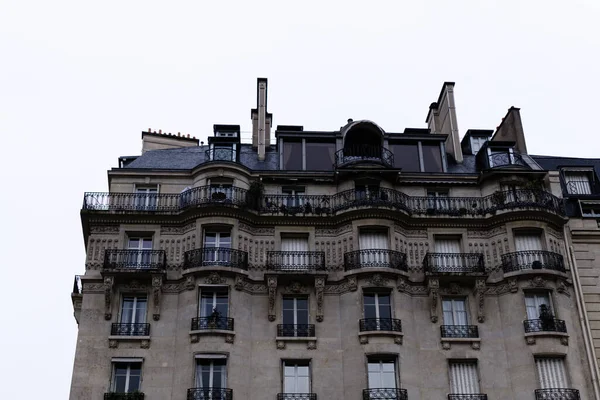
[70,79,600,400]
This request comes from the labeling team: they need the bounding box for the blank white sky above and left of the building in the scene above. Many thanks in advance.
[0,0,600,400]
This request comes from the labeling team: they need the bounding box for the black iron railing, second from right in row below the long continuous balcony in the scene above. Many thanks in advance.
[423,253,485,274]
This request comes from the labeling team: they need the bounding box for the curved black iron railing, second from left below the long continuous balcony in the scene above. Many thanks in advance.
[183,247,248,270]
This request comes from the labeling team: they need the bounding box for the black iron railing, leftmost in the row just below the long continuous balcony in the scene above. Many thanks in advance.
[104,249,166,271]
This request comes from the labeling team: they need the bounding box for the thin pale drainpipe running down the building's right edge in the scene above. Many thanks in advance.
[563,225,600,400]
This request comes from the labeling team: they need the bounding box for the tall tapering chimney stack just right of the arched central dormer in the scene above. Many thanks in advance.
[425,82,463,163]
